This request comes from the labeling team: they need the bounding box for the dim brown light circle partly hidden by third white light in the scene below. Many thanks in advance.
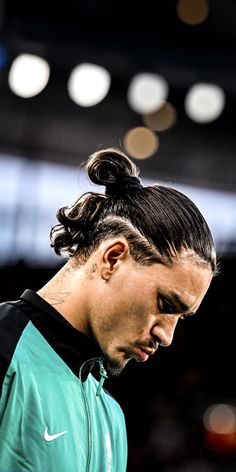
[143,102,177,131]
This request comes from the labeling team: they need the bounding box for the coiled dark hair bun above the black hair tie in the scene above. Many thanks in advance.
[86,148,139,186]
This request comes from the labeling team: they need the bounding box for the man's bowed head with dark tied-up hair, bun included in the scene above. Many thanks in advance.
[51,149,216,373]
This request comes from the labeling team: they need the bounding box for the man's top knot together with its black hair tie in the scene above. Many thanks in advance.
[86,148,142,196]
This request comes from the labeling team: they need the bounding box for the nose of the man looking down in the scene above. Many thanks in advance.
[151,314,178,347]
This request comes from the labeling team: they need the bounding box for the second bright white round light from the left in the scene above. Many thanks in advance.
[68,63,111,107]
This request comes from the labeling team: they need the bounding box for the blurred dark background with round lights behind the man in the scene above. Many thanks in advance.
[0,0,236,472]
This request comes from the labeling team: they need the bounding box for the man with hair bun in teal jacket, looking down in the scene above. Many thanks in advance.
[0,149,216,472]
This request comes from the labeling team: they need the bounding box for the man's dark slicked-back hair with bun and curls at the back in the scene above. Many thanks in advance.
[50,148,217,273]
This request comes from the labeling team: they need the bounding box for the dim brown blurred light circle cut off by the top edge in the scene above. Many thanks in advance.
[177,0,209,25]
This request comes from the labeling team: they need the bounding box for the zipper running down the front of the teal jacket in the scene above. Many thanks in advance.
[79,357,108,472]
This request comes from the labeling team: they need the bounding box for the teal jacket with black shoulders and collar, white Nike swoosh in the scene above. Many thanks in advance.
[0,290,127,472]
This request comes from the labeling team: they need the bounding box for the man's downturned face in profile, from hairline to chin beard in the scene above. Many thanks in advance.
[86,251,212,375]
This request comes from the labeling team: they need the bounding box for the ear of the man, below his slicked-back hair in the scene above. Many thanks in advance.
[101,238,130,280]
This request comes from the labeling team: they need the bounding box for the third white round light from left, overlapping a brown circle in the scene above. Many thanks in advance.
[127,73,169,115]
